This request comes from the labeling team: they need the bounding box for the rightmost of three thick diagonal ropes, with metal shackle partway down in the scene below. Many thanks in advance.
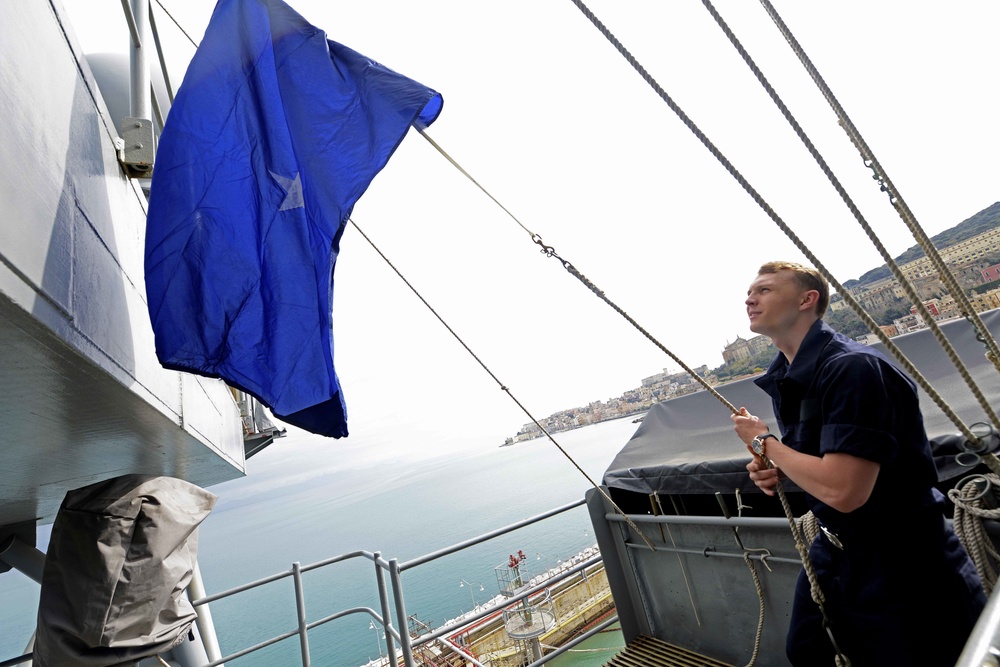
[760,0,1000,408]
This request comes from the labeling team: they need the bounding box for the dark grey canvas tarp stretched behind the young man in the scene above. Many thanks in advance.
[604,310,1000,494]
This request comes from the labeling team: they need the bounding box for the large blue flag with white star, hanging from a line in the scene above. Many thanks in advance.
[145,0,442,437]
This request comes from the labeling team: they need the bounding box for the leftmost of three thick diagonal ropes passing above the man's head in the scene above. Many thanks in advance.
[572,0,979,454]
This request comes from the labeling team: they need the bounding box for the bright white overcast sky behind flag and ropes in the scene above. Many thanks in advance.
[63,0,1000,458]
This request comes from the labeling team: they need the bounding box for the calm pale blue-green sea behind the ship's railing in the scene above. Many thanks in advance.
[0,418,636,667]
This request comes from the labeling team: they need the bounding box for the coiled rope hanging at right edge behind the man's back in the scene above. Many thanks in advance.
[948,473,1000,595]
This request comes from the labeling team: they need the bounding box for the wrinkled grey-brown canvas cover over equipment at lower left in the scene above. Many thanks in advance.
[34,475,216,667]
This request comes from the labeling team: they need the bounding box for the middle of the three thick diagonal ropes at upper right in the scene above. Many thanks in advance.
[702,0,1000,440]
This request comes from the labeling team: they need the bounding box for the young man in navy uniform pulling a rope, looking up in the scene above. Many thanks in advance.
[732,262,986,667]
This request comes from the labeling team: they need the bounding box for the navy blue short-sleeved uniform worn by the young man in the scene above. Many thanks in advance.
[755,320,986,667]
